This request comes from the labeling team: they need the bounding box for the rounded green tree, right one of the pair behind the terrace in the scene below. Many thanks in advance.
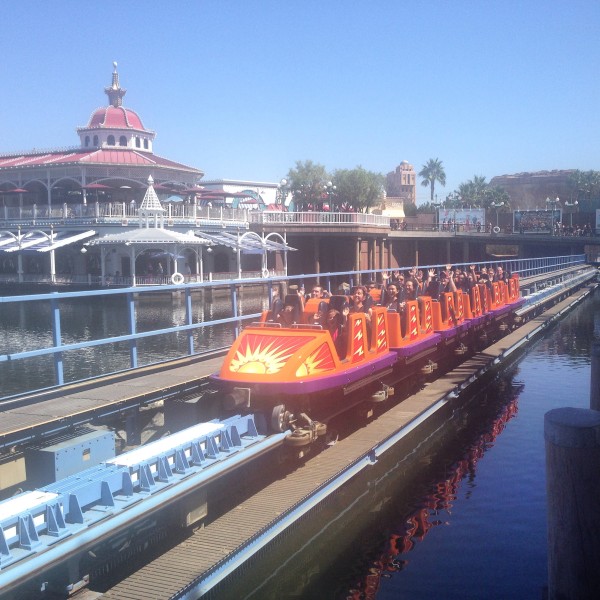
[332,166,385,212]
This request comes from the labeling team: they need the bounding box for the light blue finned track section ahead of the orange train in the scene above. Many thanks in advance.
[0,415,287,591]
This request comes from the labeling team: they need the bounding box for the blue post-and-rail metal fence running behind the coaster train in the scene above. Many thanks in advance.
[0,255,586,399]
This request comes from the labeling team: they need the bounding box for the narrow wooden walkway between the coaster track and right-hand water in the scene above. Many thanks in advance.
[100,288,589,600]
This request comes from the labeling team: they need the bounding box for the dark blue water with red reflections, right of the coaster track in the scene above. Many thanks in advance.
[215,293,600,600]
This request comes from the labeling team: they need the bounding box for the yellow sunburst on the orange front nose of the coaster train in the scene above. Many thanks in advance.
[229,334,310,375]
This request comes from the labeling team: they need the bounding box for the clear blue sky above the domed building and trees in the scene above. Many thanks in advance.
[0,0,600,201]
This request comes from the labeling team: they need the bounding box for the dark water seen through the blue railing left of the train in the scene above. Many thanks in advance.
[0,293,266,397]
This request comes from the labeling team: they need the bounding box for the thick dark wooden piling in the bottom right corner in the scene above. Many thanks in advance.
[544,408,600,600]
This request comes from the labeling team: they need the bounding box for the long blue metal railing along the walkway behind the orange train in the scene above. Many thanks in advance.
[0,255,585,400]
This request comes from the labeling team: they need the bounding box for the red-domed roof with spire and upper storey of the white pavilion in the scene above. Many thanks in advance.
[0,63,203,209]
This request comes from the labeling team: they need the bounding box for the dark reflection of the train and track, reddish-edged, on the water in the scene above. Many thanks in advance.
[210,374,522,600]
